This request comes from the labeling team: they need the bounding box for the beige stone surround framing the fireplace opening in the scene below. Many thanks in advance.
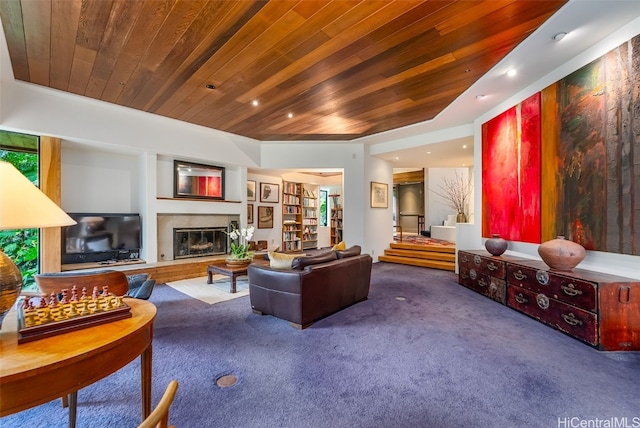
[158,214,240,261]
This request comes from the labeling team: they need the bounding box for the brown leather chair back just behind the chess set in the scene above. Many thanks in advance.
[35,270,129,296]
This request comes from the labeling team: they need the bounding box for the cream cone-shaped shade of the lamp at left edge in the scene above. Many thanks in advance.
[0,161,76,230]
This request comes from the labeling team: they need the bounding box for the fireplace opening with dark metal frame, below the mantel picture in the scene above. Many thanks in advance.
[173,227,227,259]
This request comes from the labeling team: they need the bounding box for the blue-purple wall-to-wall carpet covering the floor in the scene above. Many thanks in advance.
[0,263,640,428]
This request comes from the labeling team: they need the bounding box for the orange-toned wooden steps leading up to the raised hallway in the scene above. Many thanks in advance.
[378,242,456,271]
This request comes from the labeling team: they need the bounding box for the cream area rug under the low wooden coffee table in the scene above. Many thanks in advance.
[167,275,249,305]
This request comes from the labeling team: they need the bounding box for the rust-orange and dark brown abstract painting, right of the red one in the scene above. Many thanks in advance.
[542,36,640,255]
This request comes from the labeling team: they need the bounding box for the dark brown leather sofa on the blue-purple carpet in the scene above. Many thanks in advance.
[248,246,372,329]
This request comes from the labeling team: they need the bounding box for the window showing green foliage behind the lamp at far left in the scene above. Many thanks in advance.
[0,131,40,289]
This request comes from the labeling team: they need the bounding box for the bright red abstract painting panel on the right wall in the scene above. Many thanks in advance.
[482,92,541,243]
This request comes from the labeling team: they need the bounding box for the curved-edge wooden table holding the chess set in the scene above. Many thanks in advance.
[0,298,156,426]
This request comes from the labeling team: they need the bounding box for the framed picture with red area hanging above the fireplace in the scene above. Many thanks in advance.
[173,160,224,200]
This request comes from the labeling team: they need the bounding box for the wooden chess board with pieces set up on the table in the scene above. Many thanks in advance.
[18,290,131,343]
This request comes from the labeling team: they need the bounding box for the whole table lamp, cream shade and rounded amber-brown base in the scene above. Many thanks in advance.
[0,161,76,328]
